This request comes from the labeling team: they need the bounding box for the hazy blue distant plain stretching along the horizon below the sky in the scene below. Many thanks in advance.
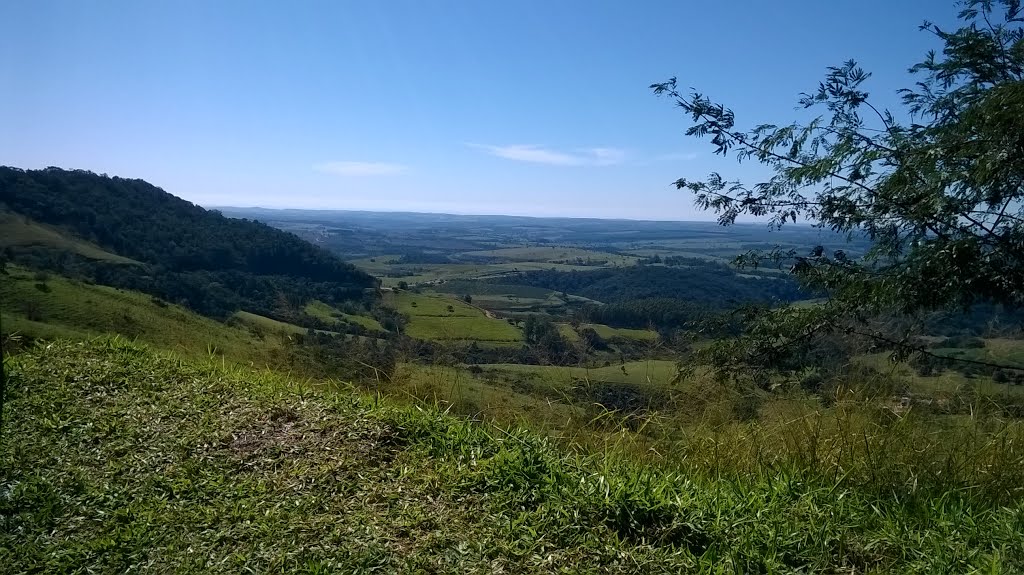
[216,208,867,265]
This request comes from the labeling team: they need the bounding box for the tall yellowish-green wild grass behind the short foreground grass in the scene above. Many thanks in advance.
[383,356,1024,503]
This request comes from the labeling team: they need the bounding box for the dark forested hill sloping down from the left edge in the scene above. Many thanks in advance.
[0,167,376,317]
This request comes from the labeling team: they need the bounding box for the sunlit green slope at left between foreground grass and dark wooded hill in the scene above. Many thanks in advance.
[0,266,282,358]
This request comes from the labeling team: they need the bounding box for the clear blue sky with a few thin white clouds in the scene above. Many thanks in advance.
[0,0,956,220]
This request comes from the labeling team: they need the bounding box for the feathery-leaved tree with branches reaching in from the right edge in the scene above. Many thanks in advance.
[651,0,1024,374]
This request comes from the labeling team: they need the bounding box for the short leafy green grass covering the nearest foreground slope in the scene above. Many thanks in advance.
[0,341,1024,573]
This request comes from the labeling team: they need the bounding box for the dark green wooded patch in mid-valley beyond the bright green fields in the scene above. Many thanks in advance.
[494,259,808,308]
